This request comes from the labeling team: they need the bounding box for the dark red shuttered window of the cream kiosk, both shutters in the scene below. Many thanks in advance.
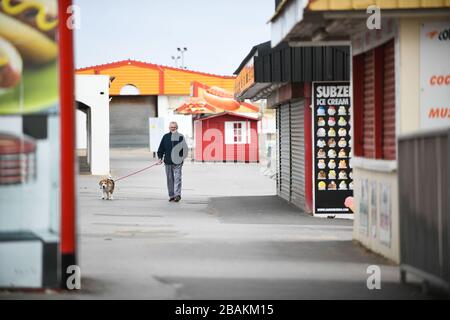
[353,40,396,160]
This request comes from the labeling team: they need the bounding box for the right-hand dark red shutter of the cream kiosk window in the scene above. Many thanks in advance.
[382,40,395,160]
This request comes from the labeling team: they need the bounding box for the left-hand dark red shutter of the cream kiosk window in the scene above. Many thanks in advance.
[361,50,375,158]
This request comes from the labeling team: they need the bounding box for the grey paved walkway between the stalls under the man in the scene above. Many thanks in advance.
[0,150,426,299]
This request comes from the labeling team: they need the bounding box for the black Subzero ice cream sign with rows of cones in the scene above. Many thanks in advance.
[312,82,353,214]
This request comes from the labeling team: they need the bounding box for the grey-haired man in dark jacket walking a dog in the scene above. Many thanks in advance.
[158,121,188,202]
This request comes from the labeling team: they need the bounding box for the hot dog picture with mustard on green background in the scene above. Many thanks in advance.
[0,0,58,115]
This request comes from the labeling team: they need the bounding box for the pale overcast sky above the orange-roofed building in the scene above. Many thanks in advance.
[74,0,275,75]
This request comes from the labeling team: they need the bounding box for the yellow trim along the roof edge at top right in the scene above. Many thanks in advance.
[308,0,450,11]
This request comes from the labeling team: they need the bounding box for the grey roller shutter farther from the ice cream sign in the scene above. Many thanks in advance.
[279,104,291,201]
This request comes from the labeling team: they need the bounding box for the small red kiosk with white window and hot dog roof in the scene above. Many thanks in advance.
[176,81,259,162]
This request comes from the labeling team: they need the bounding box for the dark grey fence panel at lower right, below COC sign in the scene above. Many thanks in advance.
[398,129,450,291]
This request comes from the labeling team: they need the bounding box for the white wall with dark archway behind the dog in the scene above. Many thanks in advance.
[75,75,110,175]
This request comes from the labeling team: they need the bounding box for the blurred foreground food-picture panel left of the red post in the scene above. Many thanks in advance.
[0,0,66,288]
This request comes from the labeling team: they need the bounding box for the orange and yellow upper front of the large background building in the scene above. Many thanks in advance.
[76,60,235,96]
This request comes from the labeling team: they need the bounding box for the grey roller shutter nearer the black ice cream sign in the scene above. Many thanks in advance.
[291,101,305,209]
